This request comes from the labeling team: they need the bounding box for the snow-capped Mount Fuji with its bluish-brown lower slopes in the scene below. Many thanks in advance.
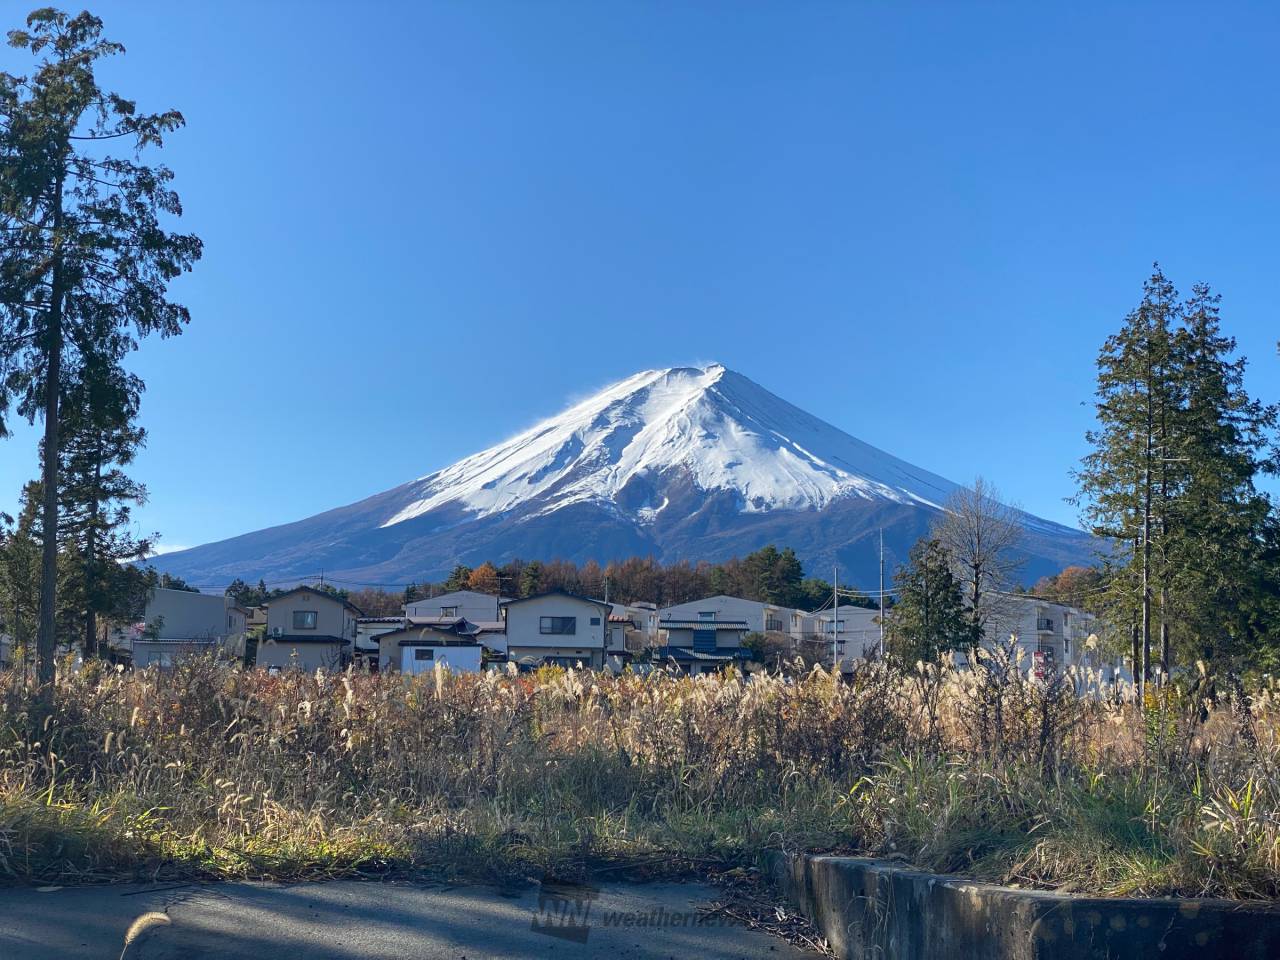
[151,364,1093,586]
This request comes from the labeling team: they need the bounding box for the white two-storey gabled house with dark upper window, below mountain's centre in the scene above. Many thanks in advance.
[502,590,621,669]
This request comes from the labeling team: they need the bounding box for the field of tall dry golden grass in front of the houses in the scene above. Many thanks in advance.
[0,657,1280,899]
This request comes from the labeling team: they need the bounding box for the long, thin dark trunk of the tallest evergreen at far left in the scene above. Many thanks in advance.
[36,177,63,692]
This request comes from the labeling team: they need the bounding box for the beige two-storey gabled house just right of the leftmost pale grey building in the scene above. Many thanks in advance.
[257,586,361,671]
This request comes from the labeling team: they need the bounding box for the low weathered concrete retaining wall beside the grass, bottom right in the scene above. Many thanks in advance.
[769,854,1280,960]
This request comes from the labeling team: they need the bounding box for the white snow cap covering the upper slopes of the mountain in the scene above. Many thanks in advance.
[381,364,955,527]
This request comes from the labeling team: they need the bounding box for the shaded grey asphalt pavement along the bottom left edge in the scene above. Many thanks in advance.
[0,882,815,960]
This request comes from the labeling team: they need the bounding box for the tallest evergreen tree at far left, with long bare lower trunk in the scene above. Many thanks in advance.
[0,8,201,684]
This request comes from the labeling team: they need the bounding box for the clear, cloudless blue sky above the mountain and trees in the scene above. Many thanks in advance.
[0,0,1280,548]
